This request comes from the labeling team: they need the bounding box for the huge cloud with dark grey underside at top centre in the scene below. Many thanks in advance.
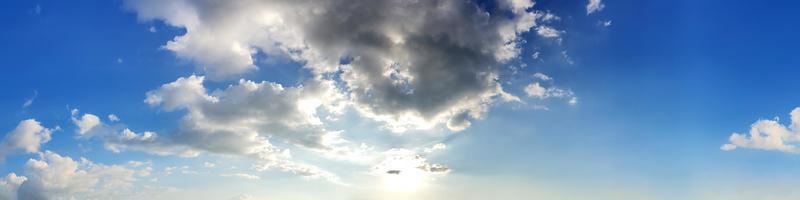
[125,0,554,132]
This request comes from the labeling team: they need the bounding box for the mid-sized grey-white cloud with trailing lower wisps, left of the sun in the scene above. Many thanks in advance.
[75,76,347,183]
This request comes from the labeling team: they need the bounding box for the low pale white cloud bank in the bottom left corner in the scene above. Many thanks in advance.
[0,151,145,199]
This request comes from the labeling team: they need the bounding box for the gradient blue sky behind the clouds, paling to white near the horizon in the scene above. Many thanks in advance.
[0,0,800,200]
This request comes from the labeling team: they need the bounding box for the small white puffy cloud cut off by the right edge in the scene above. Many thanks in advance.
[720,107,800,153]
